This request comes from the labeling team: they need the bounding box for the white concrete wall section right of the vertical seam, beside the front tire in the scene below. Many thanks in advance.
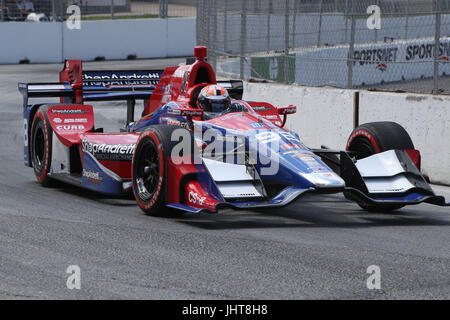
[359,91,450,185]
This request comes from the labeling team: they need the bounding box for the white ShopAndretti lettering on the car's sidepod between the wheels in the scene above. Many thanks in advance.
[81,140,136,161]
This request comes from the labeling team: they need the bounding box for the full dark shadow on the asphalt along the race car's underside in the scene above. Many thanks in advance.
[34,182,450,230]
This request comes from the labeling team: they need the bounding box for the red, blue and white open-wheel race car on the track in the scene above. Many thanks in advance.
[19,46,449,215]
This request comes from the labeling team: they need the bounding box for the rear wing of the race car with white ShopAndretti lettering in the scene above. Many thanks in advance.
[19,60,164,123]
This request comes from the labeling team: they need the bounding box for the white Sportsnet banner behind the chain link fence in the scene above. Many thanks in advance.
[295,37,450,87]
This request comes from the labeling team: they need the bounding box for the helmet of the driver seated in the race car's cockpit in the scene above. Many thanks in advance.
[197,85,231,116]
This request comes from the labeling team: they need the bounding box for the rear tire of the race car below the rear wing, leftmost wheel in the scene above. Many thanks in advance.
[30,106,53,187]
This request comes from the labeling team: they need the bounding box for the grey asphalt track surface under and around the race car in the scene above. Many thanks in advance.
[0,59,450,299]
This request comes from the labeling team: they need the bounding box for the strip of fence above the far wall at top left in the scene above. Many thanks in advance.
[0,0,197,22]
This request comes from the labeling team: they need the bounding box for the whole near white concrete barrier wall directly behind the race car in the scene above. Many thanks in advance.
[244,83,450,185]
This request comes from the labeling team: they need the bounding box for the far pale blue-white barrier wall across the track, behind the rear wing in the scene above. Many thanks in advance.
[0,18,196,64]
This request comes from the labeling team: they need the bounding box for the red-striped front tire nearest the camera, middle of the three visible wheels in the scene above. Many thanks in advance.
[132,125,193,216]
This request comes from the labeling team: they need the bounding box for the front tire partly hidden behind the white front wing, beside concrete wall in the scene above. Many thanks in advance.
[346,121,414,213]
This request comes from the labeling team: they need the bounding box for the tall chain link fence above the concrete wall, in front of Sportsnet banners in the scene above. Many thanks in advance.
[197,0,450,94]
